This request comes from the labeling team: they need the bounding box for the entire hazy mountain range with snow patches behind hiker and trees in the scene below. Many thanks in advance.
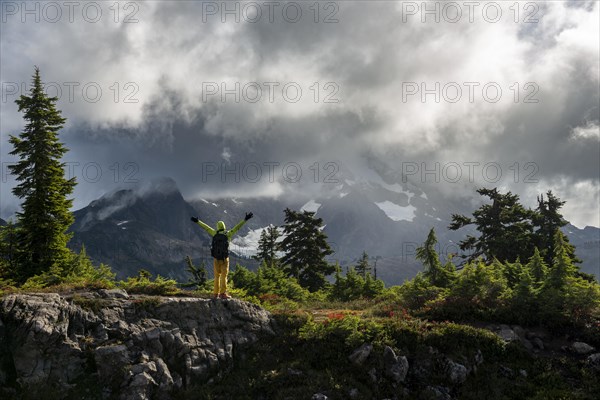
[70,174,600,285]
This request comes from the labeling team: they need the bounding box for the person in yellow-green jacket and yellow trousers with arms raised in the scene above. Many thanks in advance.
[190,212,253,299]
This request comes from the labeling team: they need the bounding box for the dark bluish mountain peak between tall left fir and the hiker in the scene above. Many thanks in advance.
[69,178,260,280]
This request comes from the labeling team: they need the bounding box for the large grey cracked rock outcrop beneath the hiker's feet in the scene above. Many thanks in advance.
[0,290,273,399]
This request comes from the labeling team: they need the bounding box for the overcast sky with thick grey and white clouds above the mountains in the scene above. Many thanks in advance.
[0,0,600,227]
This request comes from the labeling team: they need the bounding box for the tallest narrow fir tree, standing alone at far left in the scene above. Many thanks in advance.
[9,67,75,282]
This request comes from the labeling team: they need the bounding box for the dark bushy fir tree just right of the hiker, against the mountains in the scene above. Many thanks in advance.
[280,208,335,291]
